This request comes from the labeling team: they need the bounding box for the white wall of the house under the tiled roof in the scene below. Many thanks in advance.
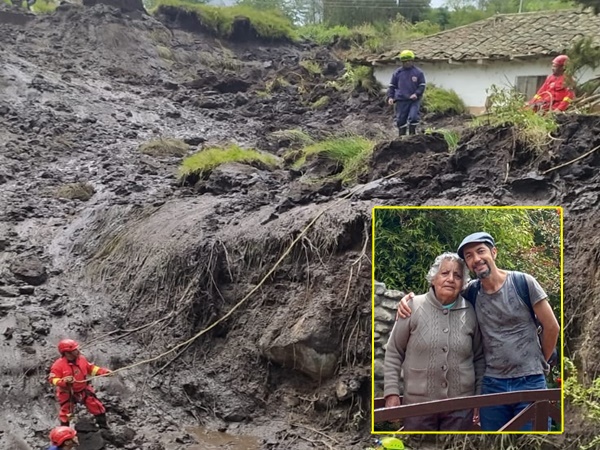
[374,57,593,112]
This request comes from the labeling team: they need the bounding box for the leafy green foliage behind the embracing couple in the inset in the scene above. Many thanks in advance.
[374,208,561,311]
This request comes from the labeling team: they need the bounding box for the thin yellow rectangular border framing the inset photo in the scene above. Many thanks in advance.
[371,205,565,436]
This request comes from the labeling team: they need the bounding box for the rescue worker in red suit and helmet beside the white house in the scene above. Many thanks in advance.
[528,55,575,111]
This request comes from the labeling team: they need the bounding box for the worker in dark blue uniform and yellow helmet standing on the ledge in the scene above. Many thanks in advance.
[387,50,425,136]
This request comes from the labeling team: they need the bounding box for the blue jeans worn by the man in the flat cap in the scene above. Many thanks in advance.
[479,375,547,431]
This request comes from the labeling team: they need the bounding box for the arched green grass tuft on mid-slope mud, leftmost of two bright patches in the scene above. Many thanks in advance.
[179,144,279,182]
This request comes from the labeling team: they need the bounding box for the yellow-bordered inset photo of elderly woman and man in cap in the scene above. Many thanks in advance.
[371,206,564,434]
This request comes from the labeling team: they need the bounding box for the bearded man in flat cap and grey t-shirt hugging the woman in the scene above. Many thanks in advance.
[398,232,560,431]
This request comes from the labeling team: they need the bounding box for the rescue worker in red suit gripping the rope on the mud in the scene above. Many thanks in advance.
[48,339,112,428]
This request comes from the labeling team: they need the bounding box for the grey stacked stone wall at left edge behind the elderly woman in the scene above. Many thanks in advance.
[373,281,404,397]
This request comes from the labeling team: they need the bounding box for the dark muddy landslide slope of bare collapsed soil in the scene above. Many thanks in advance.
[0,5,600,450]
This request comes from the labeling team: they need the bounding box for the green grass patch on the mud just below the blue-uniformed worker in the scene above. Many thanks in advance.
[292,136,375,184]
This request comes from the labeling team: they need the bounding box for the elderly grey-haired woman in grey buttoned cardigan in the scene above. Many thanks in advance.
[384,253,485,431]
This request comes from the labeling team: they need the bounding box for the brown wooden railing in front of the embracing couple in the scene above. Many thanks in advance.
[374,389,561,431]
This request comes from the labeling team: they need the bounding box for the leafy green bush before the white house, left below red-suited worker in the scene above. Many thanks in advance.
[471,85,558,154]
